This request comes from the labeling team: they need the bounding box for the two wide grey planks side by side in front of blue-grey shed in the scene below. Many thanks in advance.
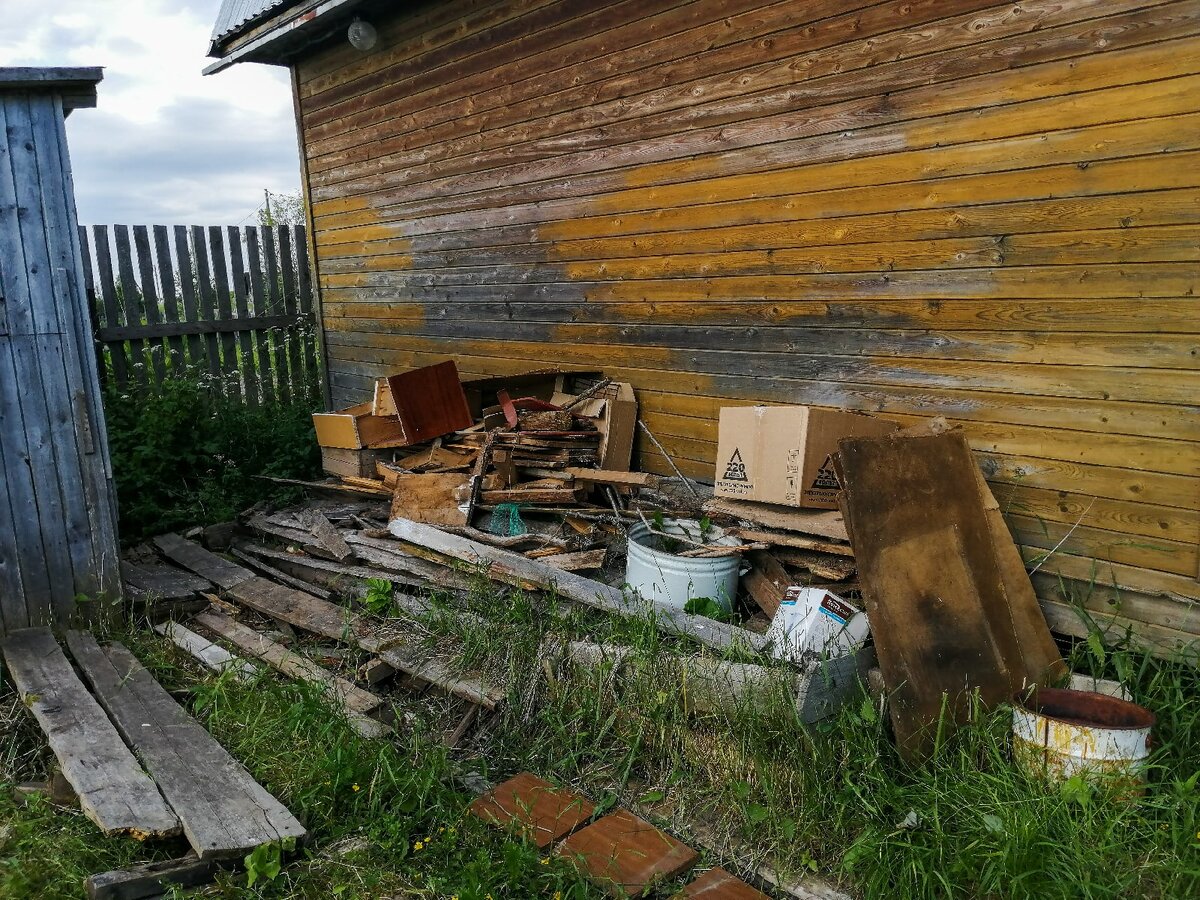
[0,628,306,860]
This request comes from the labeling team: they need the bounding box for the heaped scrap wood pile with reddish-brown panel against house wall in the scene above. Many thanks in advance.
[294,361,649,568]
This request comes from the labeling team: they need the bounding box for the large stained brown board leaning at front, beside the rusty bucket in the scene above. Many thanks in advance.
[839,433,1025,762]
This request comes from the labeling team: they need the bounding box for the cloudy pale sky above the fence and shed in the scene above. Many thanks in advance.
[0,0,300,224]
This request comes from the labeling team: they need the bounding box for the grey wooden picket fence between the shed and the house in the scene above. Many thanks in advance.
[79,224,319,406]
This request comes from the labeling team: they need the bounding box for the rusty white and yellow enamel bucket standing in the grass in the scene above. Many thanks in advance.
[1013,688,1154,780]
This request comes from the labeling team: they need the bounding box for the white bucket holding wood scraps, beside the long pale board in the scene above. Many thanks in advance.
[625,518,742,611]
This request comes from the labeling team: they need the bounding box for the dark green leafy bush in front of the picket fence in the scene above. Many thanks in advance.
[104,377,320,544]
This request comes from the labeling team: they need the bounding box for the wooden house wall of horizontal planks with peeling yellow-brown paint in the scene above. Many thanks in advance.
[294,0,1200,648]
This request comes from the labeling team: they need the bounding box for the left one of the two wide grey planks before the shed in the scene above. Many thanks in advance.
[0,628,180,840]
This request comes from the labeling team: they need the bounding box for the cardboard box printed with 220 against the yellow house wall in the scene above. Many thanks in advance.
[714,407,899,509]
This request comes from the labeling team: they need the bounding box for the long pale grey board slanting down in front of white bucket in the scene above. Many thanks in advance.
[388,518,764,650]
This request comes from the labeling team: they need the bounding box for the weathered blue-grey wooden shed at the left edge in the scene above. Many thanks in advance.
[0,67,120,634]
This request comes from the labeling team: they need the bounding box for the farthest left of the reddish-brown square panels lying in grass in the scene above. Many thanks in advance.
[469,772,595,850]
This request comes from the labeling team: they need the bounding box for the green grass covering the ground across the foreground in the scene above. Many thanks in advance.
[0,582,1200,900]
